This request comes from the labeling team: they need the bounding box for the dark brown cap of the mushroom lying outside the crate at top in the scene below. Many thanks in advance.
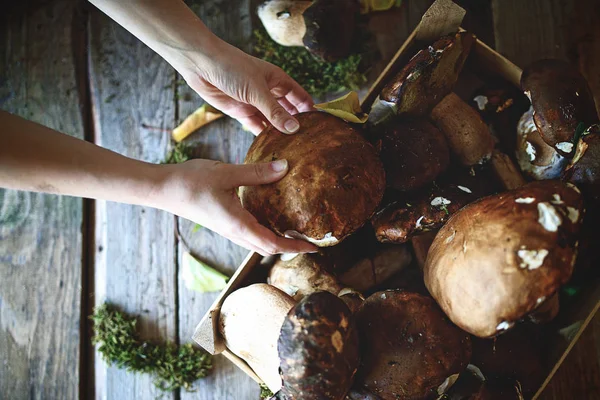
[302,0,360,62]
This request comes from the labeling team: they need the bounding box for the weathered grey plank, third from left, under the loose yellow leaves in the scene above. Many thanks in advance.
[177,0,259,400]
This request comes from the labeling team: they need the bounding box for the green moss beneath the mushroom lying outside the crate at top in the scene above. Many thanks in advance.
[254,30,367,97]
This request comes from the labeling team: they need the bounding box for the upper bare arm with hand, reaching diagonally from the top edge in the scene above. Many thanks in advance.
[90,0,313,134]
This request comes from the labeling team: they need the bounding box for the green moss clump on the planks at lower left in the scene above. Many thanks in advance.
[91,303,212,391]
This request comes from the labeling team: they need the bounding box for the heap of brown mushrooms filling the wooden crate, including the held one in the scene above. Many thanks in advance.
[219,25,600,400]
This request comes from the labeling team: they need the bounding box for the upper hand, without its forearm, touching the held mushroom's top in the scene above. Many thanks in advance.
[180,42,313,135]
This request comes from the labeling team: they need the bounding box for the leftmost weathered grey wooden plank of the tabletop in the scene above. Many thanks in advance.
[0,1,84,399]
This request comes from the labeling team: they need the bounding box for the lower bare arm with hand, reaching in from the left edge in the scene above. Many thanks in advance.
[0,111,316,255]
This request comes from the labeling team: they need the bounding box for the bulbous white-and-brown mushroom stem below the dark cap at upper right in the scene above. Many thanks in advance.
[516,107,568,180]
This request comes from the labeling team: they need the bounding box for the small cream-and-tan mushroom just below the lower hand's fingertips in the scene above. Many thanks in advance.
[269,254,343,301]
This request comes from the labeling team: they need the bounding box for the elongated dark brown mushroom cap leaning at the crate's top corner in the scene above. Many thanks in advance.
[380,32,475,116]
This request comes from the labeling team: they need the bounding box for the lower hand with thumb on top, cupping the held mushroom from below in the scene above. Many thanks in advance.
[158,160,317,256]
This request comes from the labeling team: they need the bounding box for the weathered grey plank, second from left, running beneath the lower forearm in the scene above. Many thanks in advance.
[89,9,177,399]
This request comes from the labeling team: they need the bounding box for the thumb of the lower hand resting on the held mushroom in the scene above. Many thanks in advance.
[227,160,288,187]
